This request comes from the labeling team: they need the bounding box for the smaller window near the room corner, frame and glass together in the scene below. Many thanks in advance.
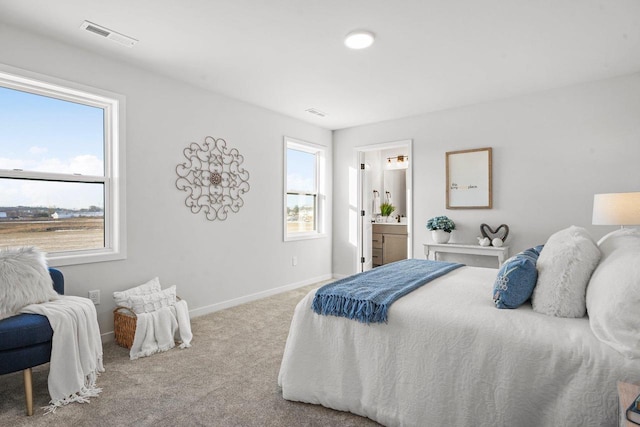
[284,137,325,240]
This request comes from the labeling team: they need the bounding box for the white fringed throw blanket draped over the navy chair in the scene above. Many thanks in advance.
[21,295,104,412]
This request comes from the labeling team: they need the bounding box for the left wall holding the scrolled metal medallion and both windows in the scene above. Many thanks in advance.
[0,26,332,333]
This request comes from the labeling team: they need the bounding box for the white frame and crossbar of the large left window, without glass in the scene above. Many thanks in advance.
[0,64,127,267]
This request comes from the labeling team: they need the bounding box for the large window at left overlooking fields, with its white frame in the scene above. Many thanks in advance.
[0,67,125,265]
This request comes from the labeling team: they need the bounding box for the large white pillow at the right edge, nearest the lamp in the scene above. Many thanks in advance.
[587,228,640,358]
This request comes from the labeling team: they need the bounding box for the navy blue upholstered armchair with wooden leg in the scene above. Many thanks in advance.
[0,268,64,415]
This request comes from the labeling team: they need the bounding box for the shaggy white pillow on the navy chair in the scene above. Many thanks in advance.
[0,247,58,319]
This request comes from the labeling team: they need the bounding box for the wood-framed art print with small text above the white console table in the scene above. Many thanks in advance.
[446,147,493,209]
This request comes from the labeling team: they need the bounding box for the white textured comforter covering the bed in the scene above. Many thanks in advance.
[278,267,640,426]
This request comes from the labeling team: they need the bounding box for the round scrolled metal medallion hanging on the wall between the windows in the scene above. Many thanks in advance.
[176,136,250,221]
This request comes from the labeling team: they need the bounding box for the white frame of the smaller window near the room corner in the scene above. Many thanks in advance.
[282,136,327,242]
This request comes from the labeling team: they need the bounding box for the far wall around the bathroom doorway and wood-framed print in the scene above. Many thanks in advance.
[333,74,640,275]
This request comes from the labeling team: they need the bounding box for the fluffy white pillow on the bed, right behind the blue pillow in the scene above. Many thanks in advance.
[531,226,601,317]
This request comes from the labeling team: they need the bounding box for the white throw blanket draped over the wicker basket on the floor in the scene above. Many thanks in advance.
[129,300,193,360]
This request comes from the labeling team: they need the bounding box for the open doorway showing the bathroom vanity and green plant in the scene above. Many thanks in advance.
[355,139,413,271]
